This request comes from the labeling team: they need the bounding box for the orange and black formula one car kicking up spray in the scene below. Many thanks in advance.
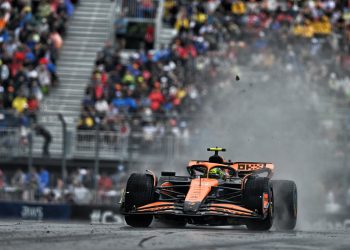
[121,147,297,230]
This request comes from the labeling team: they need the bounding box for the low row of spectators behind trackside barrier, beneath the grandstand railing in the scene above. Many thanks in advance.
[0,164,126,204]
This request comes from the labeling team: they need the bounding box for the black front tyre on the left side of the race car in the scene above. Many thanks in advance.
[124,174,154,227]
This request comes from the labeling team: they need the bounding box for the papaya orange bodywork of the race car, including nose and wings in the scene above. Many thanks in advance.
[128,161,274,218]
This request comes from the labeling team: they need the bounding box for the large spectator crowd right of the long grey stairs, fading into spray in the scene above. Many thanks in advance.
[78,0,350,143]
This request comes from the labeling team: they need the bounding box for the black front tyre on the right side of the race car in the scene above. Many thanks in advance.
[243,177,274,231]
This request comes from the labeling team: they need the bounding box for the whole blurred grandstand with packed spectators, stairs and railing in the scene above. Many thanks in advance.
[0,0,350,217]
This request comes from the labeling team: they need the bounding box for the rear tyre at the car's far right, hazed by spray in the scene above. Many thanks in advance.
[272,180,298,230]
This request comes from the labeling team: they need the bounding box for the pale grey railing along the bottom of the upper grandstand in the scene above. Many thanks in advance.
[0,124,182,161]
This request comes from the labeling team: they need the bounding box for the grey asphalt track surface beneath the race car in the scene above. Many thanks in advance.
[0,221,350,250]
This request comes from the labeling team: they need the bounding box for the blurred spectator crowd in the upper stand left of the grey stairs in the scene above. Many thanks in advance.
[0,0,77,126]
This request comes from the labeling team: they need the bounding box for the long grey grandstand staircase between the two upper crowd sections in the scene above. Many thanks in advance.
[33,0,115,157]
